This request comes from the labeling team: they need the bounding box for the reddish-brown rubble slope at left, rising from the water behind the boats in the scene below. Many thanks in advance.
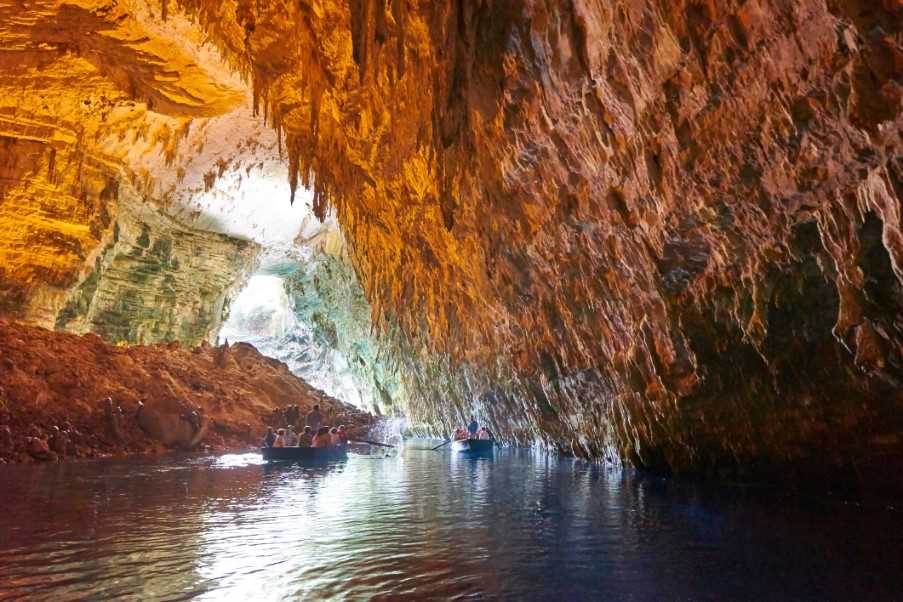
[0,320,373,462]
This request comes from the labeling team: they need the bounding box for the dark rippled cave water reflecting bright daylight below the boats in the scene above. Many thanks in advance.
[0,449,903,602]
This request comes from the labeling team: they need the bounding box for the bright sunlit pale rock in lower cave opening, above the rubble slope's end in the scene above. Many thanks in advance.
[219,238,404,413]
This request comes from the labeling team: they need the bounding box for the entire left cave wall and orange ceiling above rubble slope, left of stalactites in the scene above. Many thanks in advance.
[0,0,268,344]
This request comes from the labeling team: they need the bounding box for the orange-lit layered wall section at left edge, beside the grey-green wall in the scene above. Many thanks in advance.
[0,131,119,323]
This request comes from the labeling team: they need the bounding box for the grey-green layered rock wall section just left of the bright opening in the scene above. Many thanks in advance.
[54,198,259,345]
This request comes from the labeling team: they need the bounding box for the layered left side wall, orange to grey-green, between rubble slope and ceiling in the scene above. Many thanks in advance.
[0,115,259,344]
